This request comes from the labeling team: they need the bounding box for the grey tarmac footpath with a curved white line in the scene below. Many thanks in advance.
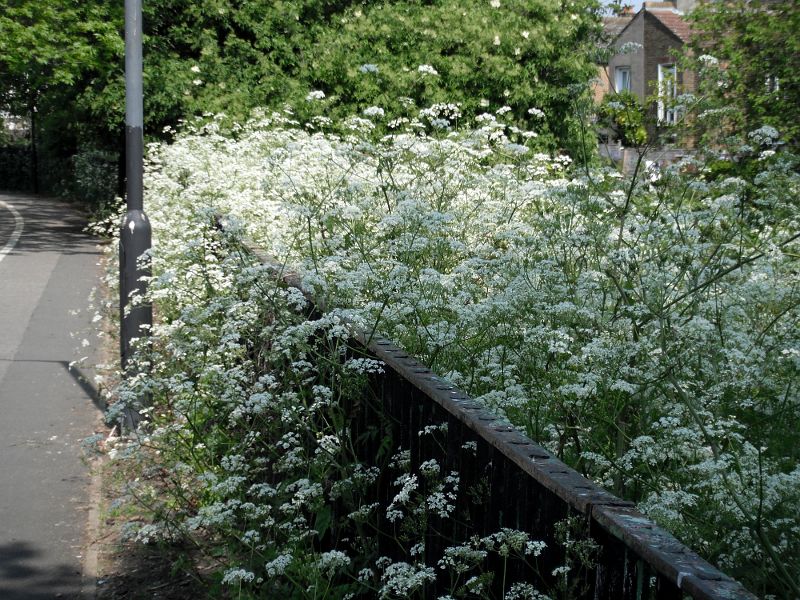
[0,194,100,600]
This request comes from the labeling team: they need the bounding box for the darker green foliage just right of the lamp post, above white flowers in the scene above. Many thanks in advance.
[131,0,352,133]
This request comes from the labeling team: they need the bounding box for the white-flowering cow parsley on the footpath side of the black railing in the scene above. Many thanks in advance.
[106,210,544,598]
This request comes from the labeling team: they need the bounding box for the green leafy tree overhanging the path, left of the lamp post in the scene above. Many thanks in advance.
[0,0,123,192]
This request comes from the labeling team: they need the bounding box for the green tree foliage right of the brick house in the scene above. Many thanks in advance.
[690,0,800,148]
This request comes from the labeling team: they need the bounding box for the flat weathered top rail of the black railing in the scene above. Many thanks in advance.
[230,232,757,600]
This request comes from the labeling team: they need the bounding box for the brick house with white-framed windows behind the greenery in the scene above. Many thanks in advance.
[595,0,697,144]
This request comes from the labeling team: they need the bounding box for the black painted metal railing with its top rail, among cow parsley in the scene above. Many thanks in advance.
[233,231,756,600]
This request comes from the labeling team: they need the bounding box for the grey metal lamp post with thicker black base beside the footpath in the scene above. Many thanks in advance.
[119,0,153,418]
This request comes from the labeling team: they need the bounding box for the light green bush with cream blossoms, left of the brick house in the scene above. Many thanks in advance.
[308,0,599,149]
